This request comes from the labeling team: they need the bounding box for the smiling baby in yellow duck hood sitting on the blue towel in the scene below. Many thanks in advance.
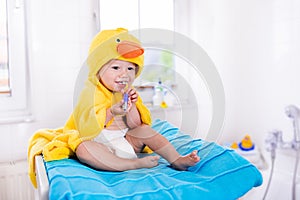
[66,28,200,171]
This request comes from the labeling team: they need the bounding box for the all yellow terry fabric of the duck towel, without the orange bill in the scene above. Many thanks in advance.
[28,28,151,187]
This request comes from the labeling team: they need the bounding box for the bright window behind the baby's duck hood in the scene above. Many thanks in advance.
[99,0,175,86]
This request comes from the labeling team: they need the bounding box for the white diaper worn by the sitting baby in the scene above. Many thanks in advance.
[94,128,137,159]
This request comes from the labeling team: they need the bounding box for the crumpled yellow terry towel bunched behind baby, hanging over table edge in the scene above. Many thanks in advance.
[28,128,81,188]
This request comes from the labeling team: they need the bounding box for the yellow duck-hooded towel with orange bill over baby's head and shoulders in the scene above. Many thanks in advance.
[64,28,151,140]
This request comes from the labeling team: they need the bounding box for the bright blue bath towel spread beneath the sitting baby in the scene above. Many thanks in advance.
[45,120,262,200]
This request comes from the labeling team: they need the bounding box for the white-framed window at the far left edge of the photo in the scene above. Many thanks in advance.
[0,0,29,123]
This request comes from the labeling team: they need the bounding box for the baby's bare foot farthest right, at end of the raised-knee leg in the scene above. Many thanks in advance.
[172,150,200,171]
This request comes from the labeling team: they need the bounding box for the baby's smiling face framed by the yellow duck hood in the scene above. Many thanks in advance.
[97,60,136,92]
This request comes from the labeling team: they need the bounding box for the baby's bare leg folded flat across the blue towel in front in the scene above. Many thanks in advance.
[76,141,159,171]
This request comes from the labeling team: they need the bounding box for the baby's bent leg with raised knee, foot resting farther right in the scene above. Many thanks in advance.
[126,125,200,170]
